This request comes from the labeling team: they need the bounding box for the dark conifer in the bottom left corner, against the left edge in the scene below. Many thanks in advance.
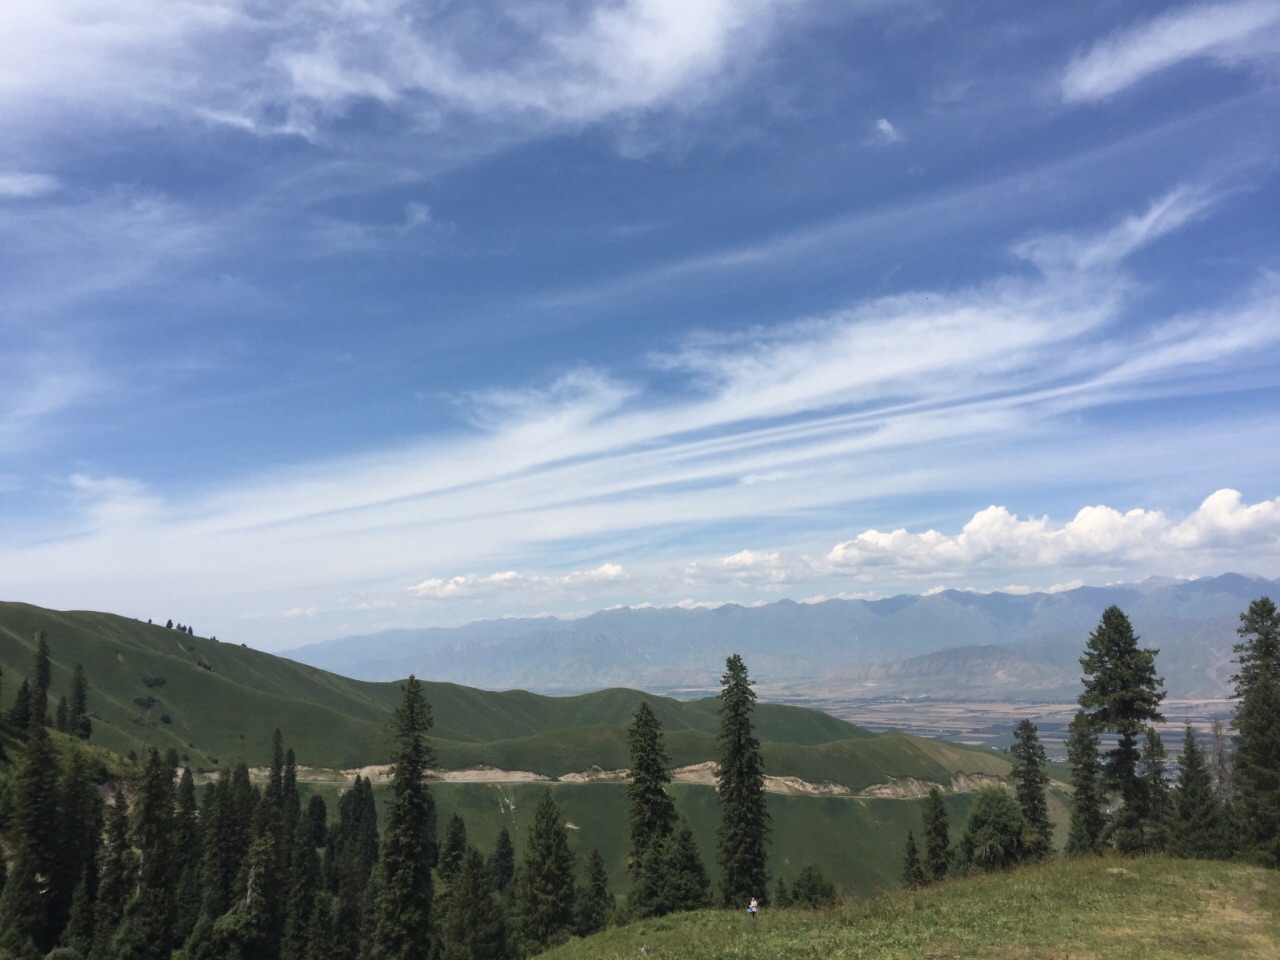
[0,724,63,954]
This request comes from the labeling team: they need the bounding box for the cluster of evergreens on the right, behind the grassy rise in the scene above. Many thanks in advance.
[902,596,1280,888]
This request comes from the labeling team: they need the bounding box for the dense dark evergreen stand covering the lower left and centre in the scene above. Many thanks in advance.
[0,650,778,960]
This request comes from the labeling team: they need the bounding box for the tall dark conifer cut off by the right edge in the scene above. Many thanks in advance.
[1231,596,1280,867]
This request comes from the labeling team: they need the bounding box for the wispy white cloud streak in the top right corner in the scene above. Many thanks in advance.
[1061,0,1280,102]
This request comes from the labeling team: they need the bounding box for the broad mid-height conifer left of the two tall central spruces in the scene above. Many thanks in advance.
[515,790,576,954]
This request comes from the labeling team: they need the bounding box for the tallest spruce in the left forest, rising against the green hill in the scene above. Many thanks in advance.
[366,676,435,960]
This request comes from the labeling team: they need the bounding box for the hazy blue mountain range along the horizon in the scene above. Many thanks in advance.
[285,573,1280,699]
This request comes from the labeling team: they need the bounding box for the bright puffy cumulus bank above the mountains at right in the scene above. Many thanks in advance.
[827,490,1280,577]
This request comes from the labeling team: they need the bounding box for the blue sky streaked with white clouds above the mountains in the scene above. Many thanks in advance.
[0,0,1280,650]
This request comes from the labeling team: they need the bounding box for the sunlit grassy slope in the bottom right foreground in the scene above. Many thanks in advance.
[543,858,1280,960]
